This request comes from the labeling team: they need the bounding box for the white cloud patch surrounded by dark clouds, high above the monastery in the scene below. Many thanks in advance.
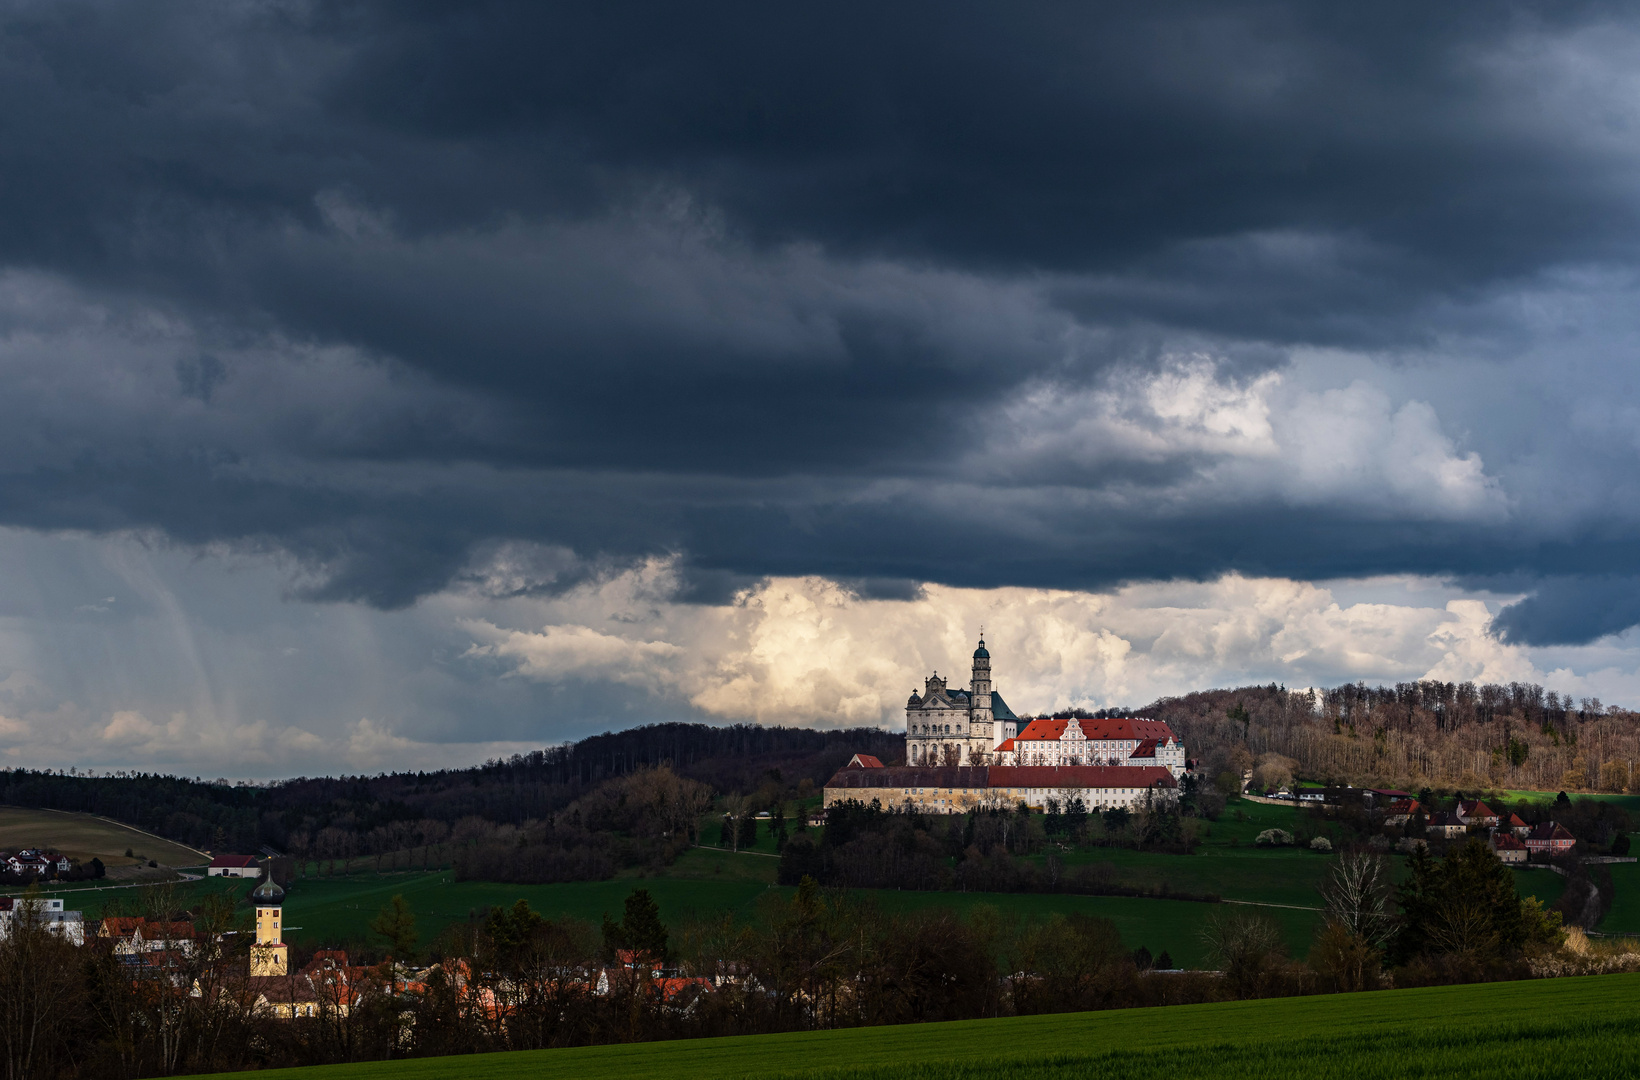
[973,354,1509,521]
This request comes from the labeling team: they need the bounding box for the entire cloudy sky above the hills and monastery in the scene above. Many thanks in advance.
[0,0,1640,777]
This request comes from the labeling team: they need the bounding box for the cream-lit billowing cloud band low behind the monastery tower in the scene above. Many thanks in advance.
[466,569,1543,724]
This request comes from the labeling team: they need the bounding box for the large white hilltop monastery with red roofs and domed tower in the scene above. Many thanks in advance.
[825,638,1189,813]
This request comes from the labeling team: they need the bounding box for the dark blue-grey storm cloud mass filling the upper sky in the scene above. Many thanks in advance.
[0,3,1640,641]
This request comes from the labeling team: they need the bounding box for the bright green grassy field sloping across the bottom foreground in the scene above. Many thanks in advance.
[211,975,1640,1080]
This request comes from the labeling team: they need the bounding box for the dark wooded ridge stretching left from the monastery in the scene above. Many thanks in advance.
[0,723,902,882]
